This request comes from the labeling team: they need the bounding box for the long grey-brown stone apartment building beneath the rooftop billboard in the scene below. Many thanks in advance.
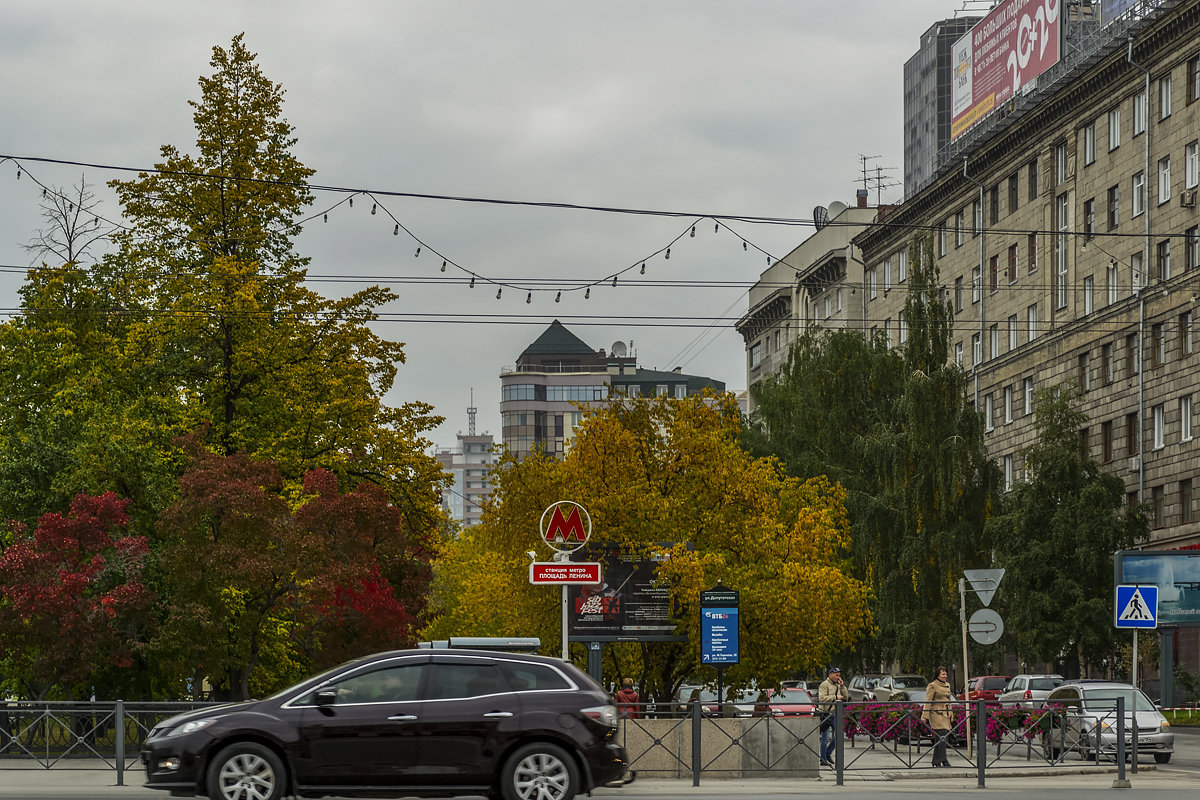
[854,0,1200,695]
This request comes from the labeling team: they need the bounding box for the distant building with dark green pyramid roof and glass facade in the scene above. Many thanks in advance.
[500,319,725,458]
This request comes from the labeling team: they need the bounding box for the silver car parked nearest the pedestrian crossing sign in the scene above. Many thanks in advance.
[1042,680,1175,764]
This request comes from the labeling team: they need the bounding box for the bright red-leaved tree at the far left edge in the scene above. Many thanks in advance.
[0,492,151,698]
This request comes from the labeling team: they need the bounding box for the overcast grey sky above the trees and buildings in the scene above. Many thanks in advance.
[0,0,986,446]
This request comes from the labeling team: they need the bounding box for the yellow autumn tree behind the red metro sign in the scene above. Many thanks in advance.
[428,395,871,691]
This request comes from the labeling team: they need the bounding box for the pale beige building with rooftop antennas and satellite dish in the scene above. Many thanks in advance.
[737,190,878,410]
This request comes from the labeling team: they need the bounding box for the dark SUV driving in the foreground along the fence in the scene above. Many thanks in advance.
[142,650,632,800]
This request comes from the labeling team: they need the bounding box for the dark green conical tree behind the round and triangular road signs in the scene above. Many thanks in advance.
[989,386,1148,675]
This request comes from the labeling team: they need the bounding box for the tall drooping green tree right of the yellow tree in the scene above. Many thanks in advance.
[744,231,997,669]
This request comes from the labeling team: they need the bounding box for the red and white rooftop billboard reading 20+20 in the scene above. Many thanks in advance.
[950,0,1063,139]
